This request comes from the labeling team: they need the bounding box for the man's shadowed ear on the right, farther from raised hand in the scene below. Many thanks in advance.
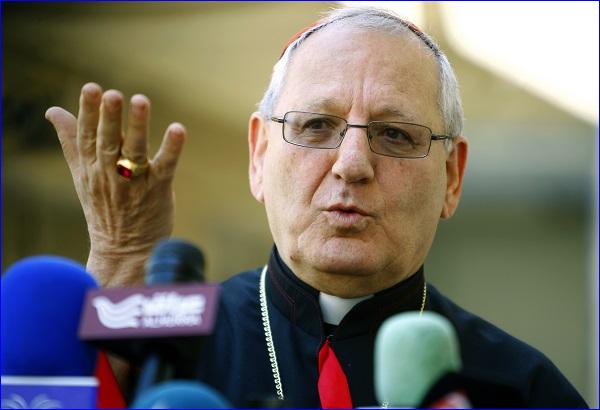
[440,136,469,219]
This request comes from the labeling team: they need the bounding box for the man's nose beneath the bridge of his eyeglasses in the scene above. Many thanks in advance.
[332,128,375,182]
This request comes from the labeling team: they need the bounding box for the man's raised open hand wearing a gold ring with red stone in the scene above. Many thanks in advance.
[46,83,186,286]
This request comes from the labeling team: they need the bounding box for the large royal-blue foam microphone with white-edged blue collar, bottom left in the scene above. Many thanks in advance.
[0,256,98,408]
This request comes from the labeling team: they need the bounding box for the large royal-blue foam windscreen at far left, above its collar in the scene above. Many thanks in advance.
[0,256,98,376]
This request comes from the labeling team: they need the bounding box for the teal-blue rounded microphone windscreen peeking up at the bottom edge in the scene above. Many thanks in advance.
[131,380,233,409]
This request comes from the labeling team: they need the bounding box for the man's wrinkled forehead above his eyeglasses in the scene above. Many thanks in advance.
[277,24,439,125]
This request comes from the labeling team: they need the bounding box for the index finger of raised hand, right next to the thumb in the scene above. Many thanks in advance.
[77,83,102,163]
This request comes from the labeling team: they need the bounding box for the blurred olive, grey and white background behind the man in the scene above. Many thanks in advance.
[1,2,598,406]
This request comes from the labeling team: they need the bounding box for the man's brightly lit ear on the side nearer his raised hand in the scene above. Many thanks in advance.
[248,112,268,203]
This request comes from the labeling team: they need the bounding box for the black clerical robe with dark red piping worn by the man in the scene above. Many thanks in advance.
[199,249,587,407]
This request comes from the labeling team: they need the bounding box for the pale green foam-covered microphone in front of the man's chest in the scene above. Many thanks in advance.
[374,312,471,408]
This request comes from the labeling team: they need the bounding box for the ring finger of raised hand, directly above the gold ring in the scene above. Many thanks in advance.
[121,94,150,163]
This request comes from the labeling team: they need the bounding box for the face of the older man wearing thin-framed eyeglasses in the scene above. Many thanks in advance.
[250,27,466,297]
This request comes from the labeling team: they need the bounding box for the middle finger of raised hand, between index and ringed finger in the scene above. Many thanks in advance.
[96,90,123,167]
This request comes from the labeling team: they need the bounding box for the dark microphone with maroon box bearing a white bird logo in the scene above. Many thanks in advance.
[80,239,219,397]
